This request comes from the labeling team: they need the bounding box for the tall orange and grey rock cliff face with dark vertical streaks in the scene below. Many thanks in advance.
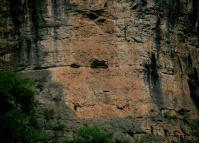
[0,0,199,142]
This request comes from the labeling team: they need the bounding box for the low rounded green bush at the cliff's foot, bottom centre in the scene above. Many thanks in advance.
[74,126,114,143]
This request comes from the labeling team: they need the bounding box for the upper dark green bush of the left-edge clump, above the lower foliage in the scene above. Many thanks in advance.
[0,72,36,113]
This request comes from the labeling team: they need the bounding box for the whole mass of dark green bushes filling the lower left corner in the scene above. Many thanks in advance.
[0,72,47,143]
